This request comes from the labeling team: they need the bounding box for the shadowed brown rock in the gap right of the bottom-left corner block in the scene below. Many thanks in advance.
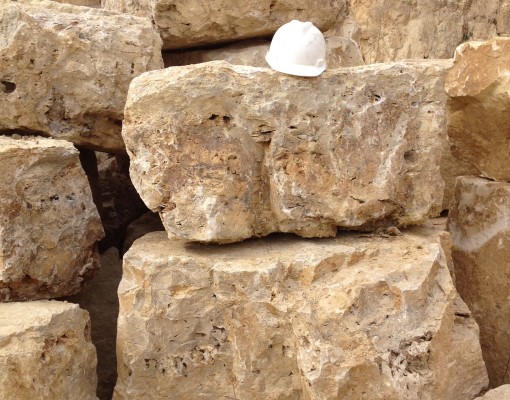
[65,247,122,400]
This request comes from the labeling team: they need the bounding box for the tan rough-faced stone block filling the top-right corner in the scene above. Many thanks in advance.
[344,0,510,64]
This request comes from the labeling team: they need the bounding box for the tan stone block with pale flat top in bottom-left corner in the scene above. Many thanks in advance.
[0,300,97,400]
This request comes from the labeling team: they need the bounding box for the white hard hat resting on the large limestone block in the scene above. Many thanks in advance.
[266,20,326,76]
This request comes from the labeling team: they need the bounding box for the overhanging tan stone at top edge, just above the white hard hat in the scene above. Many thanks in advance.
[102,0,346,49]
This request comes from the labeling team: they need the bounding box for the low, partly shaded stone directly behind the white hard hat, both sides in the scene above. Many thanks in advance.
[163,35,364,69]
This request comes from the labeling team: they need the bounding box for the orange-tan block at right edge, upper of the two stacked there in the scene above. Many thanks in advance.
[445,38,510,181]
